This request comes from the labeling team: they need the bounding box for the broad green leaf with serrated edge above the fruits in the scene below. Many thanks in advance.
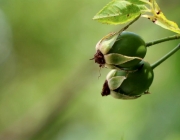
[93,0,141,24]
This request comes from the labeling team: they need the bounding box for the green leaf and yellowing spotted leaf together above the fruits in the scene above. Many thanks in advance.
[93,0,180,34]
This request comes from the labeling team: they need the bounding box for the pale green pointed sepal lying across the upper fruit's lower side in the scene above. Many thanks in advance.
[104,53,142,65]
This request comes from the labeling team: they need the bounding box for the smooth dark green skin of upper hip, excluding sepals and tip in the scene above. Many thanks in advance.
[108,31,147,67]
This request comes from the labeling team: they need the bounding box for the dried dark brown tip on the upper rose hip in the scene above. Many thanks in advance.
[91,50,105,67]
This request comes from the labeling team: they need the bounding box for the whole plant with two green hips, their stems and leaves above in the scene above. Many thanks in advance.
[93,1,180,99]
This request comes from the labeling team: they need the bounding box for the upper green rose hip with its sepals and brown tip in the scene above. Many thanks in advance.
[94,31,146,69]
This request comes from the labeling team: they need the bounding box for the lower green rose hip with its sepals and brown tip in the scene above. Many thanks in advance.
[102,61,154,99]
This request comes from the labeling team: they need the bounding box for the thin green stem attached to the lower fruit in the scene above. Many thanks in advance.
[151,44,180,69]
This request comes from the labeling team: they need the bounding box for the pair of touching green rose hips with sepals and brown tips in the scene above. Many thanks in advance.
[93,31,154,99]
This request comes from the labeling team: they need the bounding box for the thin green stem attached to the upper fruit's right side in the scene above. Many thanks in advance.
[146,34,180,47]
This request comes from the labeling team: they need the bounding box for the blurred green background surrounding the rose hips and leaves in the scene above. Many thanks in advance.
[0,0,180,140]
